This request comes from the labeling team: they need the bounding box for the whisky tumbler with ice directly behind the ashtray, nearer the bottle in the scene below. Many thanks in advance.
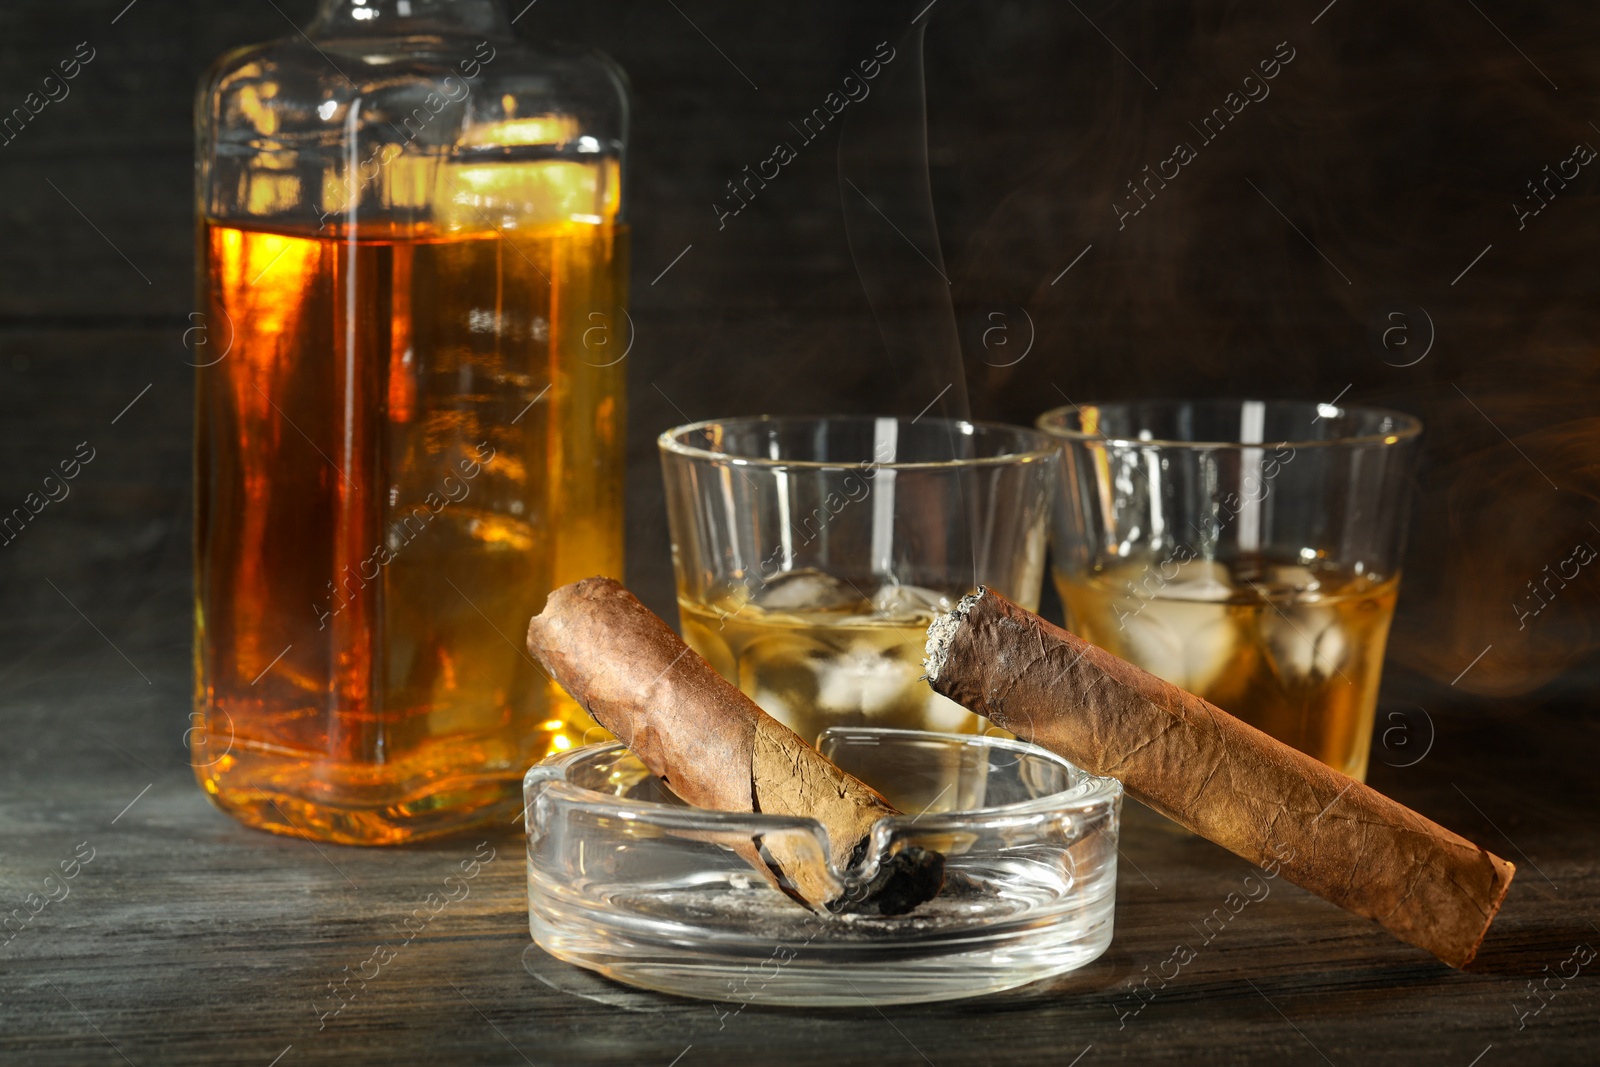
[659,416,1059,741]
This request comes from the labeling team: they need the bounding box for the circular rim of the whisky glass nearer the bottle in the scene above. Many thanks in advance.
[656,414,1061,470]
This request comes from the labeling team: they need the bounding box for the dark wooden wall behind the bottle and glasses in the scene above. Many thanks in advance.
[0,0,1600,1064]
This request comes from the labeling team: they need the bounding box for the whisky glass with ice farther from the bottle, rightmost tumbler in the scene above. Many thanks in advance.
[1038,400,1422,779]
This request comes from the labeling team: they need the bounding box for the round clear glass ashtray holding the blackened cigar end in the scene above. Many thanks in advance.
[523,726,1122,1006]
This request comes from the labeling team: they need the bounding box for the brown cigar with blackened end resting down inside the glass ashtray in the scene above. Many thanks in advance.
[528,577,944,915]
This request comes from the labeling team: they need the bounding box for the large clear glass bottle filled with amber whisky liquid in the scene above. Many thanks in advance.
[187,0,632,843]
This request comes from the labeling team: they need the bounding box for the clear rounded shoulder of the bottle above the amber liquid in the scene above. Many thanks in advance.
[195,35,629,230]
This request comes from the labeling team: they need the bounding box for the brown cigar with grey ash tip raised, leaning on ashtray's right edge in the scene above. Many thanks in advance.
[925,589,1515,968]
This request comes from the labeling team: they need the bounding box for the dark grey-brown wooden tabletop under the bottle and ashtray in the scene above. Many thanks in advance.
[0,620,1600,1067]
